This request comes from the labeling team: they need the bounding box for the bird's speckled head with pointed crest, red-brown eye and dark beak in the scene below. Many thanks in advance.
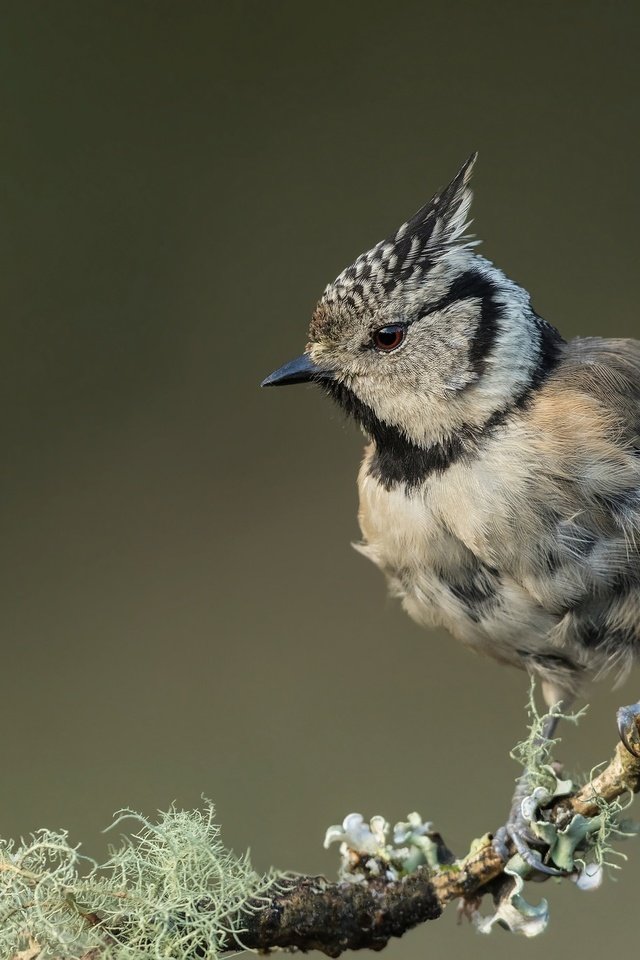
[263,155,552,456]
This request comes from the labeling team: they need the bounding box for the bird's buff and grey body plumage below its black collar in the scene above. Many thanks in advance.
[359,339,640,687]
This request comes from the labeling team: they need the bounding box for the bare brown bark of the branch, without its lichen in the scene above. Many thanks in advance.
[225,711,640,957]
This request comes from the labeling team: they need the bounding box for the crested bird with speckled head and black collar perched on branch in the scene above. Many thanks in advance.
[262,154,640,852]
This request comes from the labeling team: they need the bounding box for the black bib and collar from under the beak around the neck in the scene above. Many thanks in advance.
[322,318,563,489]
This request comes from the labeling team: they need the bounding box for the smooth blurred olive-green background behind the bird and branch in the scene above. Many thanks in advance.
[0,0,640,960]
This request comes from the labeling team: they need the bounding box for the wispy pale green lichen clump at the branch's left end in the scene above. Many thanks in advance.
[0,804,276,960]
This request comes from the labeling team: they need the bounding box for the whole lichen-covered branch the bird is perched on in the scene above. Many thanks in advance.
[5,705,640,960]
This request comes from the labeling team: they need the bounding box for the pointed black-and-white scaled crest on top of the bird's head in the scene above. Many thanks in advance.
[323,153,477,305]
